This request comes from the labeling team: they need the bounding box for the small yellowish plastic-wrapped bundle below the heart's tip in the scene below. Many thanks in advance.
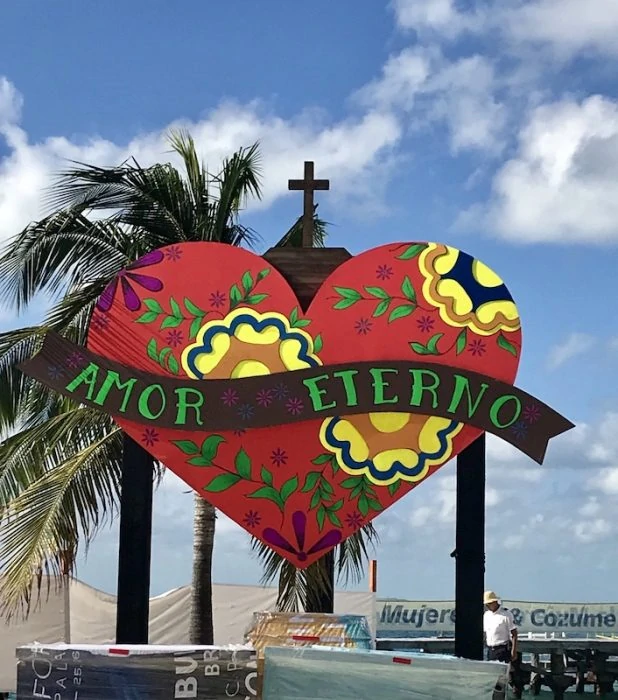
[245,612,373,658]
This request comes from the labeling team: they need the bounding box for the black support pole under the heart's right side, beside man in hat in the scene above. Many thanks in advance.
[455,433,485,659]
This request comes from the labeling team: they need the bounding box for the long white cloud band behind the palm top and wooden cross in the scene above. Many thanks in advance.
[0,79,401,245]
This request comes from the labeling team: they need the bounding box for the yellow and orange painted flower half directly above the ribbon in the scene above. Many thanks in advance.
[181,308,322,379]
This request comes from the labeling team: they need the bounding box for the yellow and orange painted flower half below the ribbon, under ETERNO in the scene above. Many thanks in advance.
[320,413,463,486]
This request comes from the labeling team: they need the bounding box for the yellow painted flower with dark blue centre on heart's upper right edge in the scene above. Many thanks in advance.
[419,243,520,335]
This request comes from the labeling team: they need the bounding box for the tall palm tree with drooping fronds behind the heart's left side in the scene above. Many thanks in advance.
[0,133,376,644]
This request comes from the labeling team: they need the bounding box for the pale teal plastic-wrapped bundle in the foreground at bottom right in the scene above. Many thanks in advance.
[262,647,508,700]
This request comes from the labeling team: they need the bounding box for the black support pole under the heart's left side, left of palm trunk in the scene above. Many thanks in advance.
[116,435,154,644]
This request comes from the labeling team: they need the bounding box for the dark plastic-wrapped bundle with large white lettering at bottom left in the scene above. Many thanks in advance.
[17,644,257,700]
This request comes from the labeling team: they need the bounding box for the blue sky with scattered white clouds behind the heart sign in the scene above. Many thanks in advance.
[0,0,618,601]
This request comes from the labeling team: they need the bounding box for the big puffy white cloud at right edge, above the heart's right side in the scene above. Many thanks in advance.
[459,95,618,244]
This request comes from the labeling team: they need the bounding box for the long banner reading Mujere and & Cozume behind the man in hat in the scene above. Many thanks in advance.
[376,599,618,638]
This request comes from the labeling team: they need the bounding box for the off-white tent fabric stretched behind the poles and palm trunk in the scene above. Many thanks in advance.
[0,579,375,691]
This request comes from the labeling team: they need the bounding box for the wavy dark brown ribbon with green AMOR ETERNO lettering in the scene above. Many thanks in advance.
[20,333,574,464]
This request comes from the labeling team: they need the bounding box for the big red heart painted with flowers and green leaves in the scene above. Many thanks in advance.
[88,243,521,568]
